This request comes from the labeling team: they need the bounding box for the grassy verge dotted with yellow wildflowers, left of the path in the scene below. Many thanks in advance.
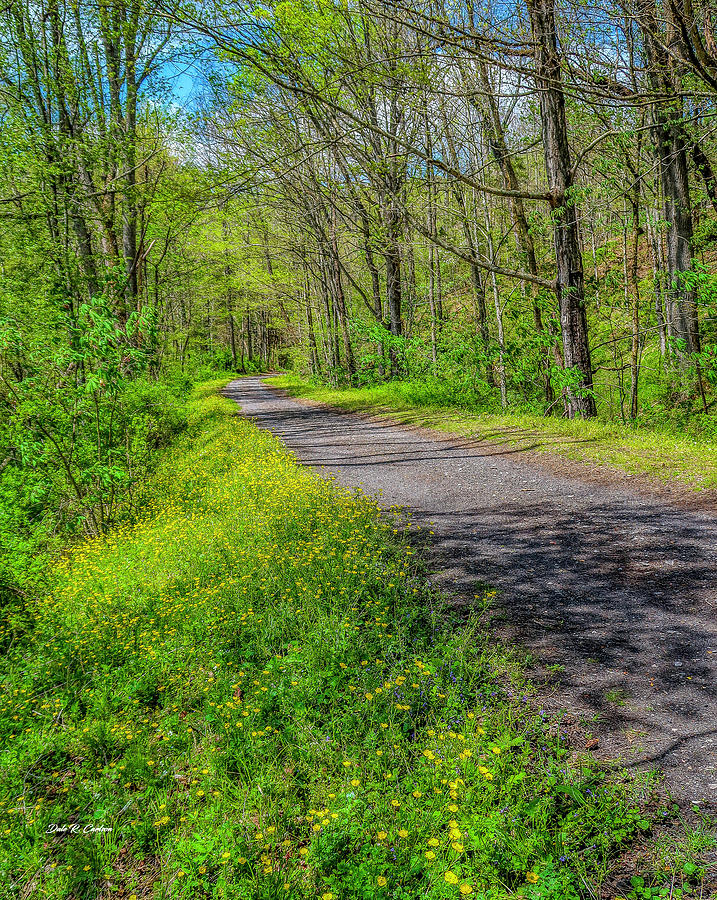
[0,385,703,900]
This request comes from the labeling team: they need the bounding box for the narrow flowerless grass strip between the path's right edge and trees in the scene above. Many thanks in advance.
[270,375,717,491]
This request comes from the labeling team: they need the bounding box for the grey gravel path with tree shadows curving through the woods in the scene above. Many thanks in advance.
[226,377,717,810]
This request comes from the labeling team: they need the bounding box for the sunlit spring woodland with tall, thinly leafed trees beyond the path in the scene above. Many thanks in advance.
[0,0,717,556]
